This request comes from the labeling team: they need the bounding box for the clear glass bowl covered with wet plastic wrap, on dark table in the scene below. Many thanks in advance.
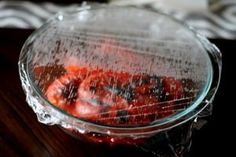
[18,6,222,157]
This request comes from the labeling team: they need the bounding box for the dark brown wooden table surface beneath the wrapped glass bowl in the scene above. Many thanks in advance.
[0,29,232,157]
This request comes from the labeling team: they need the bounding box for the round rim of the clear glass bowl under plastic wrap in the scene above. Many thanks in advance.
[19,6,219,136]
